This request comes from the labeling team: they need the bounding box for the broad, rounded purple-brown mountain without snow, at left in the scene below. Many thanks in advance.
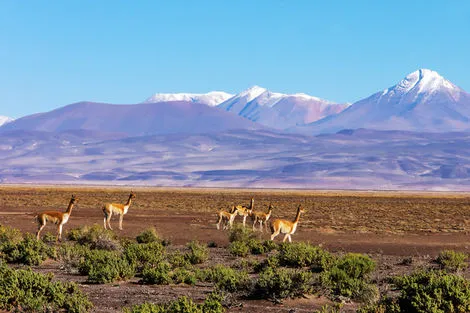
[0,101,264,136]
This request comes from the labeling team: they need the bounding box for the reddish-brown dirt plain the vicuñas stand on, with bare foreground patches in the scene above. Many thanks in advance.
[0,186,470,313]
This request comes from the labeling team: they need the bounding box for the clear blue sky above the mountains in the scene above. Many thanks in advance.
[0,0,470,118]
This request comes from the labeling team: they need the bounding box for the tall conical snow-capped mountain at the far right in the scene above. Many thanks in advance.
[292,69,470,134]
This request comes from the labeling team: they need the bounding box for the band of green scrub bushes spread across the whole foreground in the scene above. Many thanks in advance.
[0,225,470,313]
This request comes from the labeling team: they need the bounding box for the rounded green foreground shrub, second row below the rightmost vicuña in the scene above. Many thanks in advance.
[253,267,314,298]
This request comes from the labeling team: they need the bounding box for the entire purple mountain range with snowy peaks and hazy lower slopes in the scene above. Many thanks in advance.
[0,69,470,190]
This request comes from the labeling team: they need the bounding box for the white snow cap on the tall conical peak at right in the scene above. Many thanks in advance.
[383,69,459,95]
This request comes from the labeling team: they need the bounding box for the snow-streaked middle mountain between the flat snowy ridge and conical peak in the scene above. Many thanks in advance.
[218,86,349,129]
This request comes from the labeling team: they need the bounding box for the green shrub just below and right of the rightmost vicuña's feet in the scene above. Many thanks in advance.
[279,242,334,271]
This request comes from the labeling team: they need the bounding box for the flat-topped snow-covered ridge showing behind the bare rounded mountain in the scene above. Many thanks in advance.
[144,91,233,106]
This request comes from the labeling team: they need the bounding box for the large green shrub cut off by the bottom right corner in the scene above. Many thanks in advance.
[394,271,470,313]
